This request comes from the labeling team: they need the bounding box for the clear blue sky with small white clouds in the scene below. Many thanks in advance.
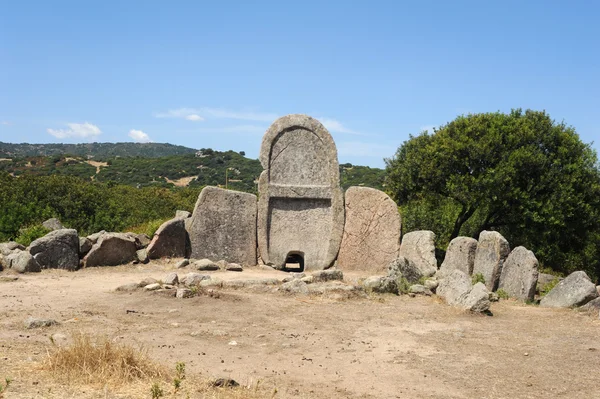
[0,0,600,167]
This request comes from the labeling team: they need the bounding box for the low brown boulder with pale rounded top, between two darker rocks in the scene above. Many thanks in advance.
[83,233,137,267]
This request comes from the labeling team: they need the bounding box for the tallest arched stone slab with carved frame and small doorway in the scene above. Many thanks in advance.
[258,115,344,270]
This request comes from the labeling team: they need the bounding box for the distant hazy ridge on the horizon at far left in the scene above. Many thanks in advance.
[0,142,196,158]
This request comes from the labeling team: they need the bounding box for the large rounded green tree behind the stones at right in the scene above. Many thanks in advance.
[386,109,600,278]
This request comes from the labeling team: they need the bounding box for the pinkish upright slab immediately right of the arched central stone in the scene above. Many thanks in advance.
[337,187,401,271]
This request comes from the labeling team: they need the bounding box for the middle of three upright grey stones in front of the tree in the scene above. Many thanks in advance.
[473,230,510,291]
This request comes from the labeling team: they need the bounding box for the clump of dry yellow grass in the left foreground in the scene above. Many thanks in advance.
[42,333,170,385]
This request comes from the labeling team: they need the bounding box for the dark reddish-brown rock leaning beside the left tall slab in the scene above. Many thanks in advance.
[147,219,188,259]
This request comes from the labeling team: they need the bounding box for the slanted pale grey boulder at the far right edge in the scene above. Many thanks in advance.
[540,271,598,308]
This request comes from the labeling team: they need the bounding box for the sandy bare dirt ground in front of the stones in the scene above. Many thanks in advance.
[0,261,600,398]
